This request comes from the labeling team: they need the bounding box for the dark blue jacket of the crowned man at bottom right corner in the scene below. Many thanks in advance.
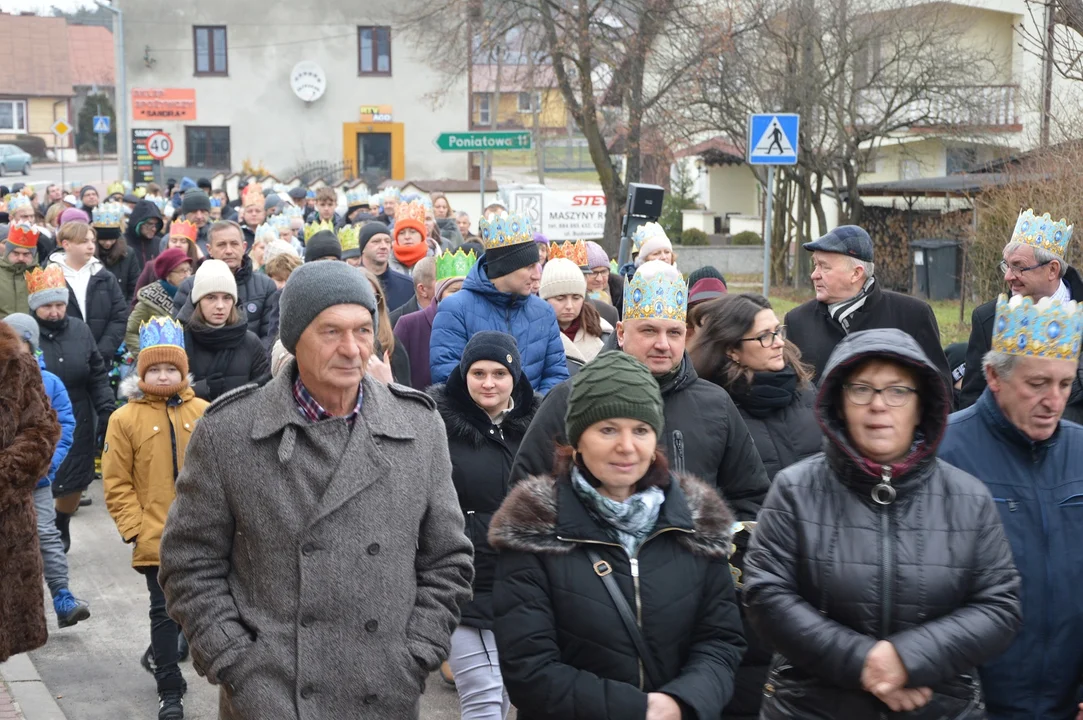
[940,389,1083,720]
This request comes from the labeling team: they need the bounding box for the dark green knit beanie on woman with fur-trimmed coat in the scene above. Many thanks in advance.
[564,350,665,447]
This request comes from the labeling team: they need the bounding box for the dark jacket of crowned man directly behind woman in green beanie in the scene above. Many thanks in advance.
[509,346,768,521]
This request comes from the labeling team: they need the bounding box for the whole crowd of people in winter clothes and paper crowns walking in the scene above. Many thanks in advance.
[0,180,1083,720]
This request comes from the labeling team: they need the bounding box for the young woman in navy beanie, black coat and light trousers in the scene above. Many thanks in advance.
[428,331,542,720]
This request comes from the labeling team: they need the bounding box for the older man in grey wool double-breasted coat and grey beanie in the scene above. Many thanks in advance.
[159,262,473,720]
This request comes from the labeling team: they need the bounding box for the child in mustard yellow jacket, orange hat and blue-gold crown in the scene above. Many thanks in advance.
[102,317,208,720]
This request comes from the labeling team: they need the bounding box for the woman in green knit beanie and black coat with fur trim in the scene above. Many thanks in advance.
[488,352,745,720]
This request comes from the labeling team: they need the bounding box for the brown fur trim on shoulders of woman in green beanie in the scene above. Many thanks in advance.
[488,474,734,559]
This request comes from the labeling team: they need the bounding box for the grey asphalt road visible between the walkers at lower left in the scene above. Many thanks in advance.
[30,482,467,720]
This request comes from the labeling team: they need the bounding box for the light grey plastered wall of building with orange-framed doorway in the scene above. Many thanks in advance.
[118,0,470,179]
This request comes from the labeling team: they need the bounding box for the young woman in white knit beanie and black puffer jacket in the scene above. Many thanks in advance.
[184,260,271,402]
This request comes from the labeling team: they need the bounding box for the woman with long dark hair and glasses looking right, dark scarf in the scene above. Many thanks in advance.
[689,292,823,477]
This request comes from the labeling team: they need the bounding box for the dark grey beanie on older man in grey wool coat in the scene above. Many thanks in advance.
[278,262,378,354]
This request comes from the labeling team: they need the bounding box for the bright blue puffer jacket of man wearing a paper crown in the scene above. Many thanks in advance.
[429,257,569,394]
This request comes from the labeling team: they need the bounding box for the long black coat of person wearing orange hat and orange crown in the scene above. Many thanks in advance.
[38,317,116,497]
